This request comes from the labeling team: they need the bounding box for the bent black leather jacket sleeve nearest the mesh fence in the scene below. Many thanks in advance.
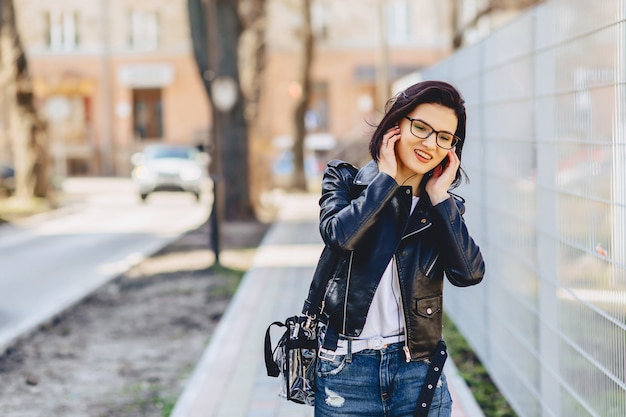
[433,196,485,287]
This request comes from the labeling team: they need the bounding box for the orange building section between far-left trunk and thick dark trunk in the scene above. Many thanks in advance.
[6,0,209,176]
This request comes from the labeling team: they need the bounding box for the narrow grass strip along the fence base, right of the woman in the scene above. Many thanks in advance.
[444,315,517,417]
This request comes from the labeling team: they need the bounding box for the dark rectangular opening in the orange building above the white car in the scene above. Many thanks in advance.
[133,88,163,139]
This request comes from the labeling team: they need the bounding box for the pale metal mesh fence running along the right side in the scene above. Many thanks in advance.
[424,0,626,417]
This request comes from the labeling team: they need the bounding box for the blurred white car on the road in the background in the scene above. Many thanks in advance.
[131,145,209,201]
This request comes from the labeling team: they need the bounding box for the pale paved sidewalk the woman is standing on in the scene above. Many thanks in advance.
[171,194,483,417]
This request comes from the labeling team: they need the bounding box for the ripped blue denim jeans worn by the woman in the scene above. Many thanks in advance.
[315,343,452,417]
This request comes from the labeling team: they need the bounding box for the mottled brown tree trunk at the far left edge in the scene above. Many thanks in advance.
[0,0,49,201]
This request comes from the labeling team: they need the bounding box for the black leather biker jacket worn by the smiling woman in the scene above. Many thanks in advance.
[320,161,485,360]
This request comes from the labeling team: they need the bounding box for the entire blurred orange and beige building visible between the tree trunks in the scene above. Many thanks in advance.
[0,0,451,180]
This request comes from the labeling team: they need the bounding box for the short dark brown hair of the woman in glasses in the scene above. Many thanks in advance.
[369,81,468,188]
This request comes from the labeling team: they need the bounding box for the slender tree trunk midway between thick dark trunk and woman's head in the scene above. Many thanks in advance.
[293,0,314,190]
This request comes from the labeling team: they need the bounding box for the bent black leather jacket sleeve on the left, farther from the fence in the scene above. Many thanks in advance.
[319,161,399,251]
